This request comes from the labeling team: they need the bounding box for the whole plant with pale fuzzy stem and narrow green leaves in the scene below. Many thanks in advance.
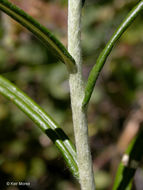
[0,0,143,190]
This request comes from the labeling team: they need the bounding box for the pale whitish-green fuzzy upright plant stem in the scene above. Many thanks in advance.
[68,0,95,190]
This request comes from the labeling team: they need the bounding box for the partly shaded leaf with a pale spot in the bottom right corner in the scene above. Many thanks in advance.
[113,126,143,190]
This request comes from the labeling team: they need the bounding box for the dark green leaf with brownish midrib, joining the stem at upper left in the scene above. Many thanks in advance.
[0,0,76,72]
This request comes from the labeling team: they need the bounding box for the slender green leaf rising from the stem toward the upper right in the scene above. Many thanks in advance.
[83,0,143,108]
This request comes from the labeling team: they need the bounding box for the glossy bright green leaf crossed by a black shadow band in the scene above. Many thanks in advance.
[0,75,78,177]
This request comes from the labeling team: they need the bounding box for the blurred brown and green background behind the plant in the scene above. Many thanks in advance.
[0,0,143,190]
